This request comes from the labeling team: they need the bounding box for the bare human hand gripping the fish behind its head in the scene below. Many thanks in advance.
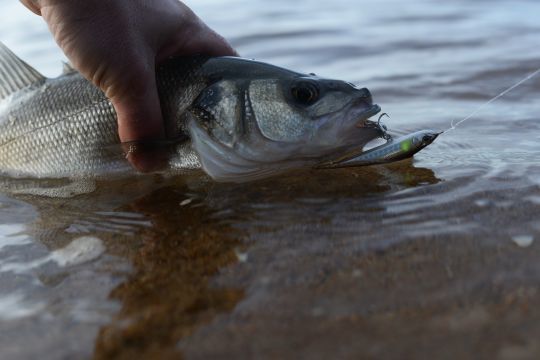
[21,0,237,171]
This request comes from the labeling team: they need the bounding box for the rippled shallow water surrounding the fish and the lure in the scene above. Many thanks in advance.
[0,0,540,359]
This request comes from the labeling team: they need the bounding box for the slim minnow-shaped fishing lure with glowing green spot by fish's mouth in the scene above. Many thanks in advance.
[318,130,442,169]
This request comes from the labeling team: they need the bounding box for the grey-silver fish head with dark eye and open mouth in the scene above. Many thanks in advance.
[188,60,380,182]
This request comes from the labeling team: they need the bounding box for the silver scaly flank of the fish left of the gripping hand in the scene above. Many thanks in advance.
[0,74,124,177]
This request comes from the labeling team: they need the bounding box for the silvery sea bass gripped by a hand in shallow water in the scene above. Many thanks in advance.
[0,44,380,182]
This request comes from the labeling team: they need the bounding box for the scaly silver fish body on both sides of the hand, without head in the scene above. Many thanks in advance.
[0,58,206,177]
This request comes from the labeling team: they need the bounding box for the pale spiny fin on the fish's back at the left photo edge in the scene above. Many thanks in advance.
[0,42,45,100]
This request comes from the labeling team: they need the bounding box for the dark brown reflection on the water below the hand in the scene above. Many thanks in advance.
[95,187,243,359]
